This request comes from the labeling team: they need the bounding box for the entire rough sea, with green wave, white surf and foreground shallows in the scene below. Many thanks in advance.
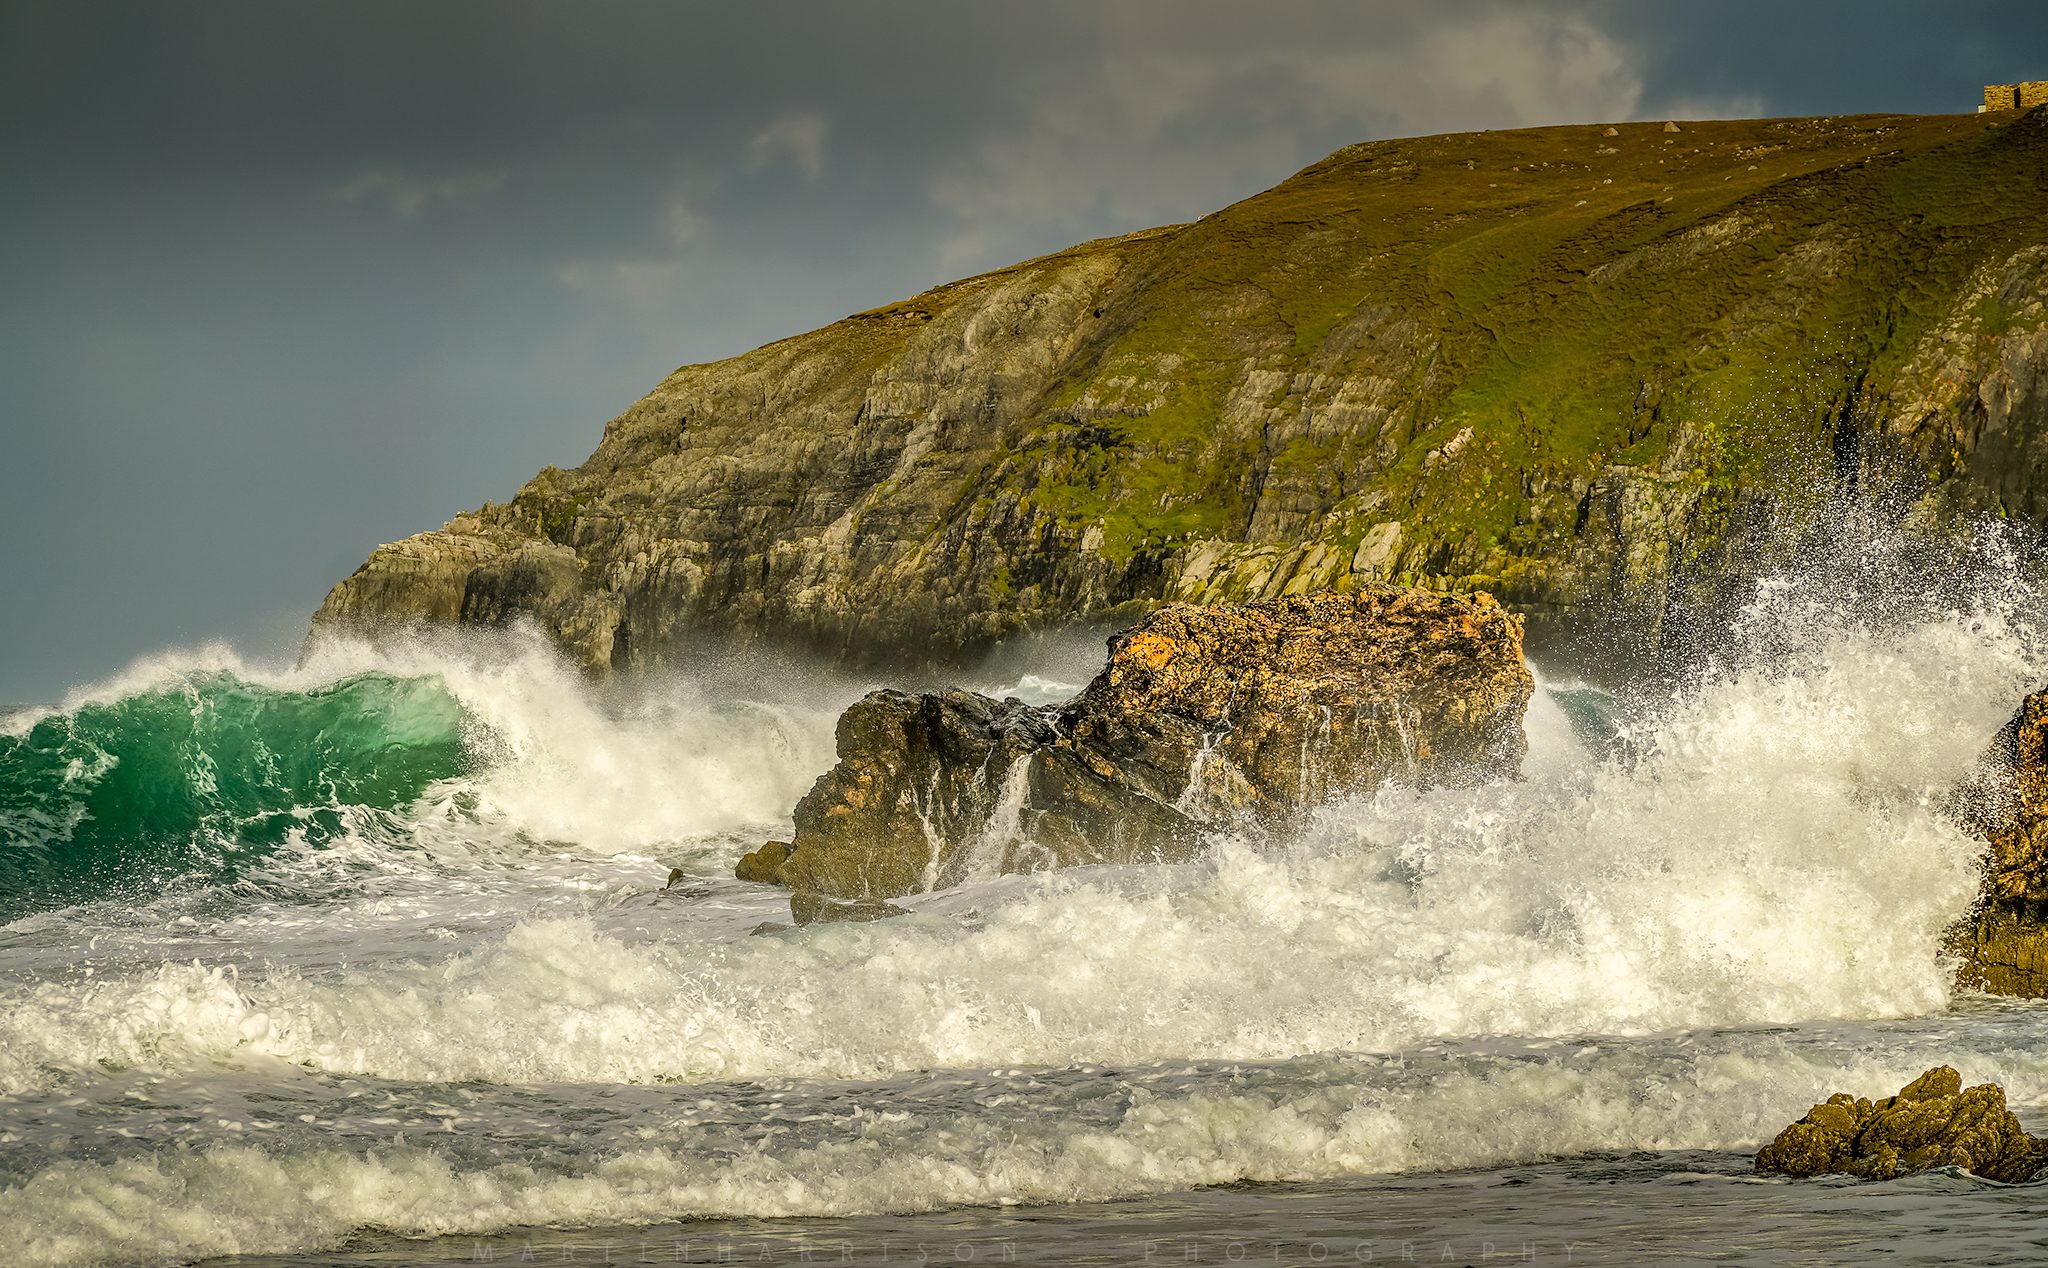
[0,548,2048,1266]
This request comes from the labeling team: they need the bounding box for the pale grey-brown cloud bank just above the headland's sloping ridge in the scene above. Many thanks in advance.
[932,4,1642,266]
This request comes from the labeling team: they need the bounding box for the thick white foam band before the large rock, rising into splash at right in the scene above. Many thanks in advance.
[0,602,2032,1090]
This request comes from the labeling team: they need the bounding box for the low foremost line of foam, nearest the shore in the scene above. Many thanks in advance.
[0,1034,2048,1266]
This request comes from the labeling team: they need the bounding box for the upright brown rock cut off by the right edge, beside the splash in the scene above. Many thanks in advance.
[1950,690,2048,998]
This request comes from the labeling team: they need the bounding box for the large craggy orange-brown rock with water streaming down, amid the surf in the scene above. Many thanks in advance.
[737,586,1534,899]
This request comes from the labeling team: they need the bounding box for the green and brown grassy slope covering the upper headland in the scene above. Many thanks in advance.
[1018,115,2048,567]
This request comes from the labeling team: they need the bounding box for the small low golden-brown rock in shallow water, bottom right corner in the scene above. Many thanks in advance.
[1757,1065,2048,1184]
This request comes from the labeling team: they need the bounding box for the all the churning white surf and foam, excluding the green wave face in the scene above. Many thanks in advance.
[0,569,2048,1264]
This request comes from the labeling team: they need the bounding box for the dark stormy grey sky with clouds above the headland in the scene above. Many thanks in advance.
[0,0,2048,703]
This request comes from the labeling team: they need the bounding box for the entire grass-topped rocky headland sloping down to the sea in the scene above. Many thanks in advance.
[315,111,2048,668]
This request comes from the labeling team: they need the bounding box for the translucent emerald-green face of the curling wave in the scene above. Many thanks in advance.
[0,672,467,922]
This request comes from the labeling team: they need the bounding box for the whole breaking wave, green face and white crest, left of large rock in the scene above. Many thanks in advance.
[0,635,854,922]
